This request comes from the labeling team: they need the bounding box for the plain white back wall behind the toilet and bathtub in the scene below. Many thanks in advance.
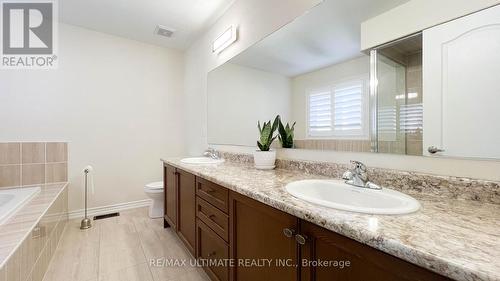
[0,24,184,210]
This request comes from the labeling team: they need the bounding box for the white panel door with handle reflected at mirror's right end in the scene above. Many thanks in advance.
[423,6,500,159]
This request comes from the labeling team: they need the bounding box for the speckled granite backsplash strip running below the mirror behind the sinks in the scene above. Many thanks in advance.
[221,152,500,204]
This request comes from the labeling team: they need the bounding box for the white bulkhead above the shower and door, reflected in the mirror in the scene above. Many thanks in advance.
[361,0,500,50]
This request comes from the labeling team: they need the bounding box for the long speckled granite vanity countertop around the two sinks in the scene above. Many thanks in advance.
[162,158,500,281]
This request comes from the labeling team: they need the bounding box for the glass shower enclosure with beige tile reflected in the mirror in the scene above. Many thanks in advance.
[372,33,423,155]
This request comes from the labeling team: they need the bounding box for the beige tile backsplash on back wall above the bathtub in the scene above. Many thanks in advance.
[0,142,68,188]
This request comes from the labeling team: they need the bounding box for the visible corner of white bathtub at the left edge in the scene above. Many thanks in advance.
[0,187,40,225]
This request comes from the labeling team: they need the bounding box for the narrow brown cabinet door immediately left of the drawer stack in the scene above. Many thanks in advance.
[177,169,196,255]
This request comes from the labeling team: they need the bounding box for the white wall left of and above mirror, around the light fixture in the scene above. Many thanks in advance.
[184,0,321,155]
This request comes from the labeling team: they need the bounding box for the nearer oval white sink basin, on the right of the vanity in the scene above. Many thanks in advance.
[285,180,420,215]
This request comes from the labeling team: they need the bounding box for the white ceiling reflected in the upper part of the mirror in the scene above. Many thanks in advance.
[231,0,408,77]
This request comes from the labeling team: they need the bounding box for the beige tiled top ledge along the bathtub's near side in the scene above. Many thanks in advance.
[0,183,68,268]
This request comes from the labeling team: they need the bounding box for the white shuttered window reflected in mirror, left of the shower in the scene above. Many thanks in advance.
[306,78,369,139]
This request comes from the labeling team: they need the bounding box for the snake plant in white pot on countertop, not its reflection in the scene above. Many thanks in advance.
[253,115,280,170]
